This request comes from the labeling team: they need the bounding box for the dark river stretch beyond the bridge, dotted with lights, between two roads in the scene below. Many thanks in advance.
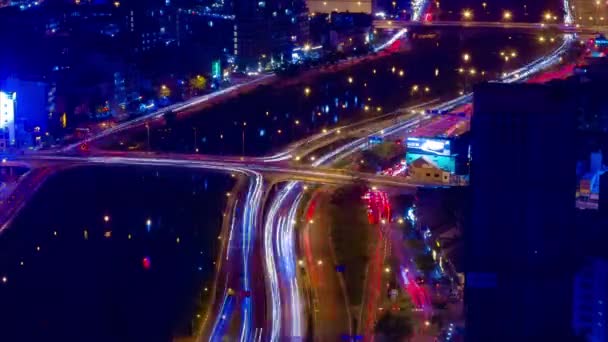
[103,29,560,155]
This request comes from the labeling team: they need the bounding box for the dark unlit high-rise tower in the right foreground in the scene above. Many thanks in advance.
[464,83,577,341]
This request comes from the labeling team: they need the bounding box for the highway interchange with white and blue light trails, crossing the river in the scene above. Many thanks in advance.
[0,9,592,341]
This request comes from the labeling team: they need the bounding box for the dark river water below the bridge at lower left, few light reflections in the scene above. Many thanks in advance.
[0,167,233,341]
